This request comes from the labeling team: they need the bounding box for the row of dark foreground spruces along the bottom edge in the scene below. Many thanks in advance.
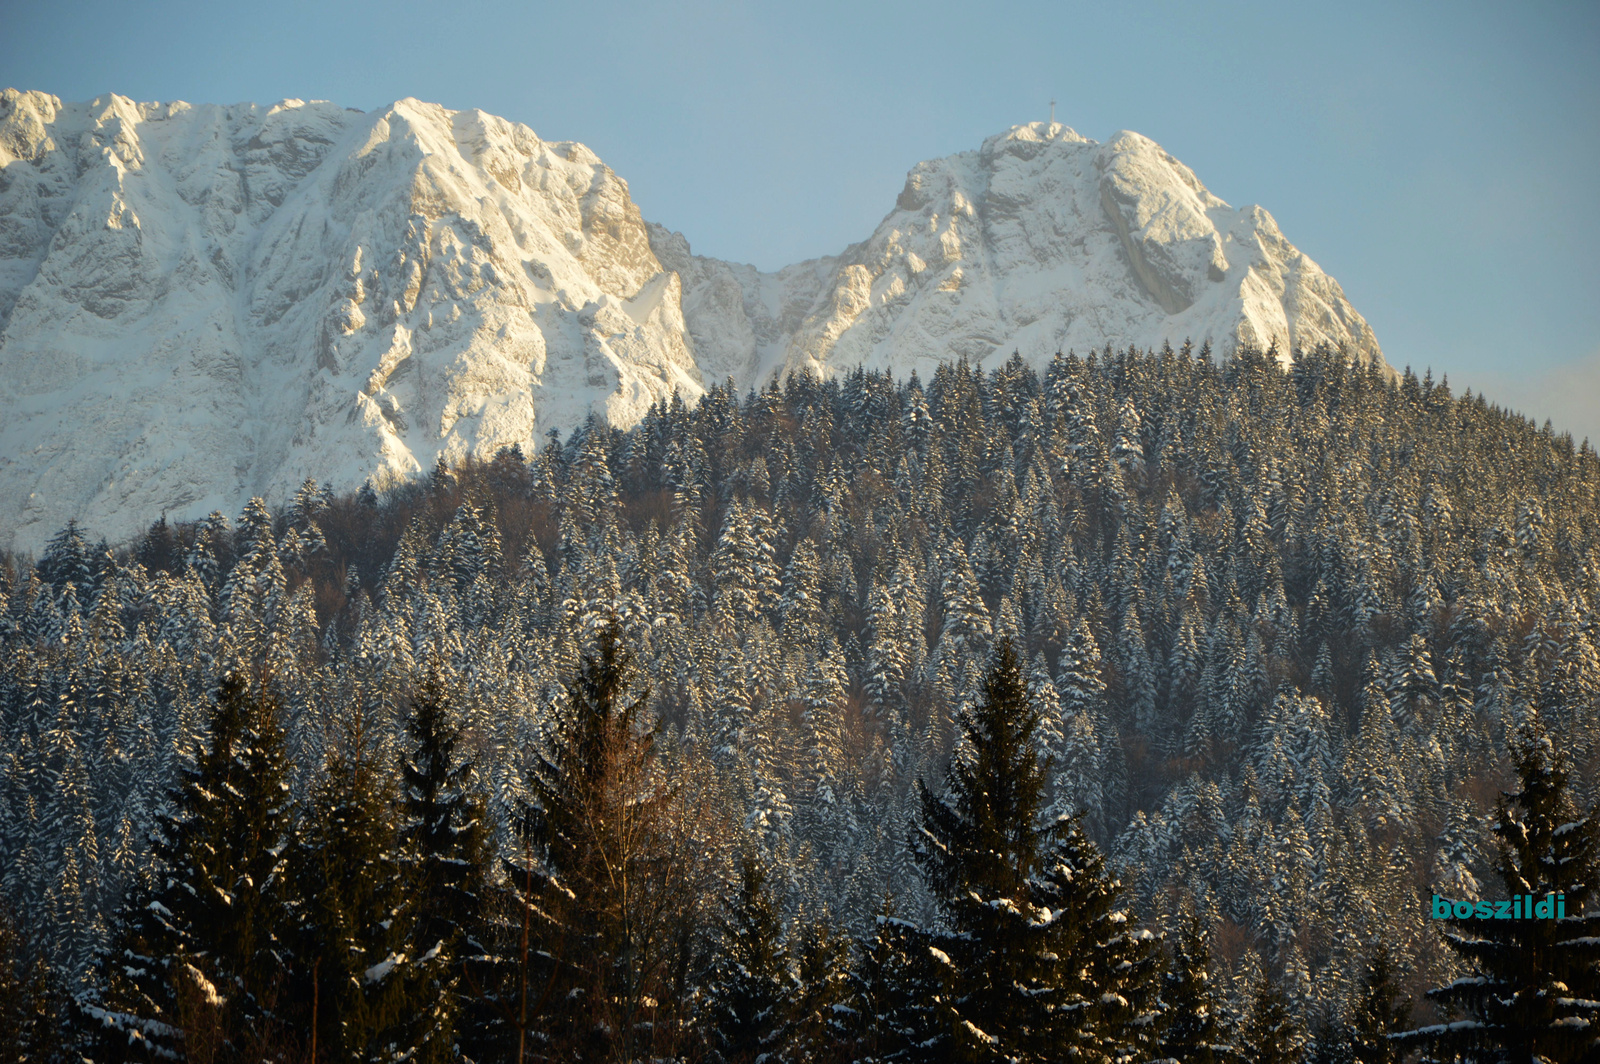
[0,624,1600,1064]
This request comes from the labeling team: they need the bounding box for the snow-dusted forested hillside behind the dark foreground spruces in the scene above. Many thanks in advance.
[0,340,1600,1056]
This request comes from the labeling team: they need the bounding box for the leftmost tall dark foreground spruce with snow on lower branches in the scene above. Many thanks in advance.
[82,672,294,1061]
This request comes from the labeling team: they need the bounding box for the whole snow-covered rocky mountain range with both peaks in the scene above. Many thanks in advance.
[0,90,1382,549]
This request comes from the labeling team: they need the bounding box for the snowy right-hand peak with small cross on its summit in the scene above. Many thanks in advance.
[651,123,1382,379]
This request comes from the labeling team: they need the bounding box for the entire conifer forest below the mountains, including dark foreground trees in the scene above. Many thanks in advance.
[0,346,1600,1064]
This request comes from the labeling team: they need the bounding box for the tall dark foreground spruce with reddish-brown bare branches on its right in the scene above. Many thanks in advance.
[501,624,710,1061]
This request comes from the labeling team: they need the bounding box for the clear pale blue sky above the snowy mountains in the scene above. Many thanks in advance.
[0,0,1600,443]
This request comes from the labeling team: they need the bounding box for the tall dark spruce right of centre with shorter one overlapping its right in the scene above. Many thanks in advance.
[912,638,1158,1061]
